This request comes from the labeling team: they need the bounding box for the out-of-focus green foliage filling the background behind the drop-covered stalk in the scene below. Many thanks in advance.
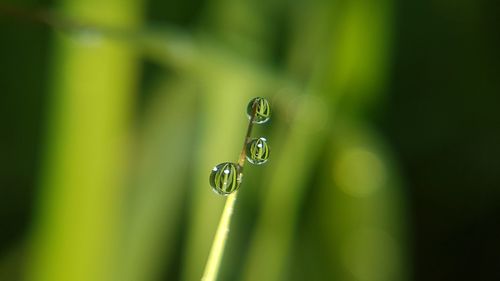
[0,0,407,281]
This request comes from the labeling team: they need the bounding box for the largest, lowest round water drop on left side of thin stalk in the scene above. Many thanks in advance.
[209,162,241,195]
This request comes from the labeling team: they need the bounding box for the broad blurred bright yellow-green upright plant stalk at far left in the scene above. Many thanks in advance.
[27,0,142,281]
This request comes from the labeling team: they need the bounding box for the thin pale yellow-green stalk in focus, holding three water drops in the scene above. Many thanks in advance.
[201,102,257,281]
